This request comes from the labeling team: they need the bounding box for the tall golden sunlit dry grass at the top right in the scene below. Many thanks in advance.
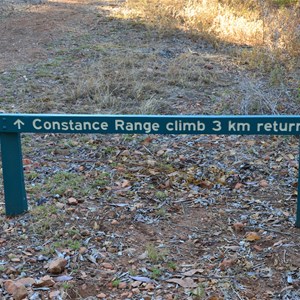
[118,0,300,67]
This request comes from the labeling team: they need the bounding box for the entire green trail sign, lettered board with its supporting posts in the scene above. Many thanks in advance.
[0,114,300,228]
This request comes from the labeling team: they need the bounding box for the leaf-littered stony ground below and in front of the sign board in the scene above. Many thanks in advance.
[0,135,300,299]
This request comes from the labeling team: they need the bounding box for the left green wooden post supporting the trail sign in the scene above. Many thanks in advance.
[0,133,28,216]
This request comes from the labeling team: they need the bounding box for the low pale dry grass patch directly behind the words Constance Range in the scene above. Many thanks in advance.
[66,53,170,114]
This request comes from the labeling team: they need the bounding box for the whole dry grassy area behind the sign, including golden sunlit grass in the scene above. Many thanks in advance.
[0,0,300,114]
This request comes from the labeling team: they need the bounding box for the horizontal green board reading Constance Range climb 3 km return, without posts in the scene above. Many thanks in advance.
[0,114,300,135]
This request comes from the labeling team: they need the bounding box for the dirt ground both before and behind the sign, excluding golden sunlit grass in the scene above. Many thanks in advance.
[0,0,300,300]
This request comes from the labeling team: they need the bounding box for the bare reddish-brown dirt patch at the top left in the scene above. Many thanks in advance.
[0,0,107,71]
